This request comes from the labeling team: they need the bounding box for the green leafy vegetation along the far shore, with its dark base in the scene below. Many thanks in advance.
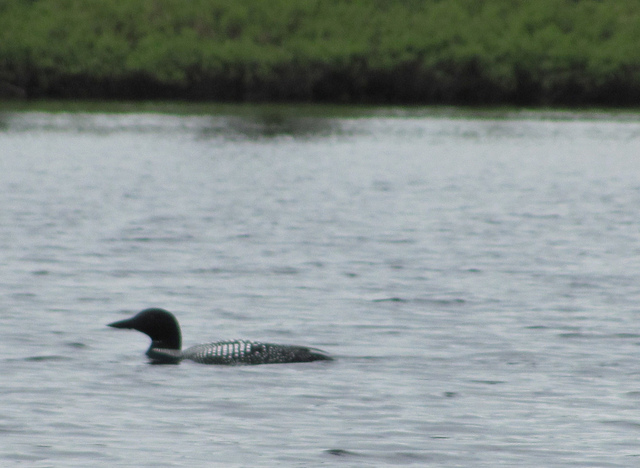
[0,0,640,106]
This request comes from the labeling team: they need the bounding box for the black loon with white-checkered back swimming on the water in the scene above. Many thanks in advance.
[109,308,333,365]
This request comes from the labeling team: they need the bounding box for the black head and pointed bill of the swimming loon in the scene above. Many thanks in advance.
[109,309,182,349]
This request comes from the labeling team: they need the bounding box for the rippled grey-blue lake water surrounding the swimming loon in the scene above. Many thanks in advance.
[0,107,640,467]
